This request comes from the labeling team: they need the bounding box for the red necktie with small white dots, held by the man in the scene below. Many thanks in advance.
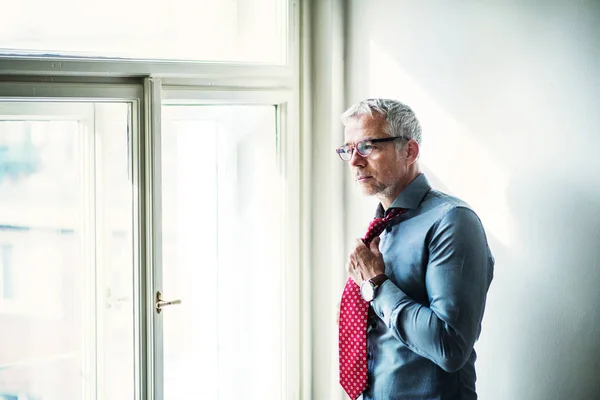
[339,208,406,400]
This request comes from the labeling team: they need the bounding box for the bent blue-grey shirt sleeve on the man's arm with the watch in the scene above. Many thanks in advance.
[372,207,492,372]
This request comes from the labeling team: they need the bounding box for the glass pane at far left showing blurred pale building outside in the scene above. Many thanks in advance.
[0,120,83,399]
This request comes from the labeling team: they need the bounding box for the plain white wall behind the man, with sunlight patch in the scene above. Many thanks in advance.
[345,0,600,400]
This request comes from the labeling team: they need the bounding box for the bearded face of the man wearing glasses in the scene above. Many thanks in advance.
[344,115,407,204]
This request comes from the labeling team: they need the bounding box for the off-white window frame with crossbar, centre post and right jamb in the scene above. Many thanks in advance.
[0,0,312,400]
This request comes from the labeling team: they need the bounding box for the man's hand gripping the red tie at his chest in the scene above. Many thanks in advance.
[346,237,385,285]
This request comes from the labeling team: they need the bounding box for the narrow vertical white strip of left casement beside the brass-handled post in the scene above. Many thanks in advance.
[94,103,134,400]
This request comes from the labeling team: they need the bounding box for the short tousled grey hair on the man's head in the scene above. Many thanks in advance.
[341,99,421,150]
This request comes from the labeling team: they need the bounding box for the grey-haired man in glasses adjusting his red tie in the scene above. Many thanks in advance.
[337,99,494,400]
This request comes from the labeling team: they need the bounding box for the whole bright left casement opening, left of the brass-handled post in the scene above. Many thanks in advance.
[0,102,133,400]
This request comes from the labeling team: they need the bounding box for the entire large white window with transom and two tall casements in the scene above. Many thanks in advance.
[0,0,302,400]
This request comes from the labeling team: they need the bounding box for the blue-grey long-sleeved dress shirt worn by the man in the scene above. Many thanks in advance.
[363,174,494,400]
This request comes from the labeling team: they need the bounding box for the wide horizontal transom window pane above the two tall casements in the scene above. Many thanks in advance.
[0,0,287,64]
